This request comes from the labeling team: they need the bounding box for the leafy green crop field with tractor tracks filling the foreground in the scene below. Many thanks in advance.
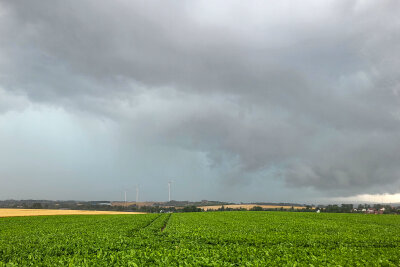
[0,212,400,266]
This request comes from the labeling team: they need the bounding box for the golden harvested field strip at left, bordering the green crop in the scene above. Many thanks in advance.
[0,209,145,217]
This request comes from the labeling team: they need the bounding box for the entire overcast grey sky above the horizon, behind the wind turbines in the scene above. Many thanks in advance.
[0,0,400,203]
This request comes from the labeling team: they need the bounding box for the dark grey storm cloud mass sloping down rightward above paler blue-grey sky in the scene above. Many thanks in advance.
[0,1,400,198]
